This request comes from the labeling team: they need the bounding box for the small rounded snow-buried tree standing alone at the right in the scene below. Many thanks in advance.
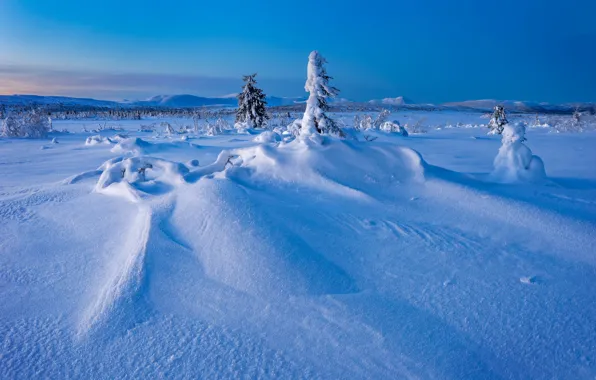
[491,123,546,183]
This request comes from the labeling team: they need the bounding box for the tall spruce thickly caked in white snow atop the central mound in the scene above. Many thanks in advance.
[300,50,345,137]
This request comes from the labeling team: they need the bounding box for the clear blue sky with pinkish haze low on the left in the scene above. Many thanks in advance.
[0,0,596,103]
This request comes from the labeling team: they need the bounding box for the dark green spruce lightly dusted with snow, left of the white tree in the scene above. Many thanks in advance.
[236,73,269,128]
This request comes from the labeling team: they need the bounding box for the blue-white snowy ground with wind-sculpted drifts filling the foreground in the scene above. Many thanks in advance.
[0,113,596,379]
